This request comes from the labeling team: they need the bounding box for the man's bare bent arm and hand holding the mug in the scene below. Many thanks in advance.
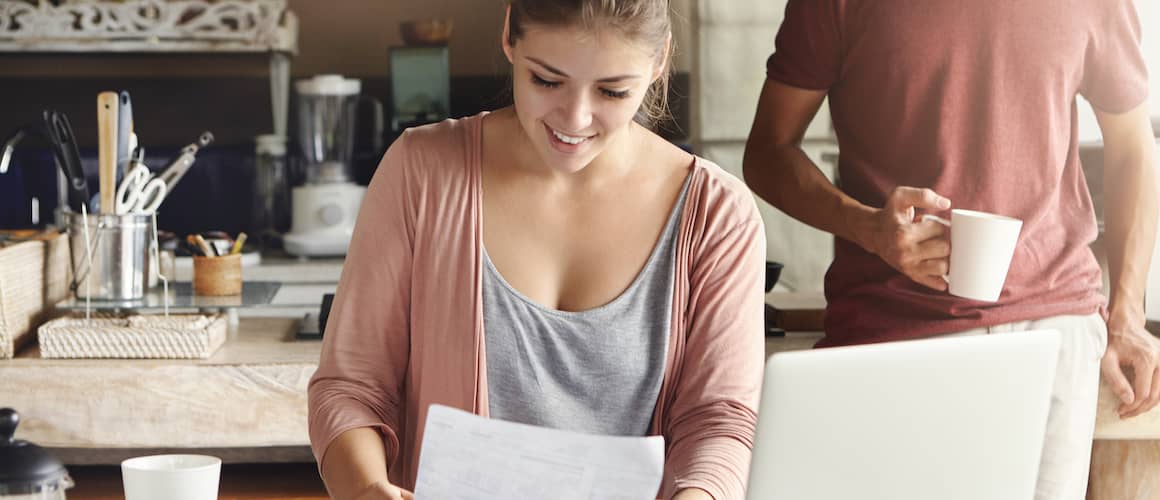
[744,80,950,290]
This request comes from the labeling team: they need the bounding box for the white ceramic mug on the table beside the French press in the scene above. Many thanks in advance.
[121,455,222,500]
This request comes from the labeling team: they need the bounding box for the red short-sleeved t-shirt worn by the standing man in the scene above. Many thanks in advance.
[768,0,1147,346]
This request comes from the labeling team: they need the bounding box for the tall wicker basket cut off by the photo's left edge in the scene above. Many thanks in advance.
[0,237,71,358]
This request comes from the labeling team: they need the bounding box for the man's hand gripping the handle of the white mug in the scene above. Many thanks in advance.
[862,186,950,290]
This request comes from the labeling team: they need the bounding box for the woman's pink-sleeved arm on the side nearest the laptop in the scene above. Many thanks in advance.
[662,211,766,500]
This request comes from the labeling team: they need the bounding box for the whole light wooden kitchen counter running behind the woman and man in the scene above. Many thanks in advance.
[0,294,1160,500]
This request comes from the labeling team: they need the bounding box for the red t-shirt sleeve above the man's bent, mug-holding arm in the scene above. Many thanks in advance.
[766,0,842,90]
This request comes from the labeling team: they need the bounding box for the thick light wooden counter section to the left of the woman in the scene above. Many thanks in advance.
[0,318,319,464]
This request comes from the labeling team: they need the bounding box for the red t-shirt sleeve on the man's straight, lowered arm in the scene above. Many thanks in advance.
[1080,0,1148,113]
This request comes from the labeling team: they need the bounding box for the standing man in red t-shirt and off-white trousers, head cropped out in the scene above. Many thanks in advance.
[745,0,1160,500]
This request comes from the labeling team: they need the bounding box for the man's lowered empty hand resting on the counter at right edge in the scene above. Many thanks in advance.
[1100,318,1160,419]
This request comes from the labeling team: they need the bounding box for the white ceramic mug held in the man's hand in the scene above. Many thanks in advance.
[922,209,1023,302]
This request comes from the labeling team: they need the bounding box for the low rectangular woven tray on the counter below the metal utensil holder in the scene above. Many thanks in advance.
[37,314,226,360]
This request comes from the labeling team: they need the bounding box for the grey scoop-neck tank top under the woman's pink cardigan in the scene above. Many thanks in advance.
[483,177,689,436]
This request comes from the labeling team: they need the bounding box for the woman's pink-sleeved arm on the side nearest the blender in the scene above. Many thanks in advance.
[307,133,415,498]
